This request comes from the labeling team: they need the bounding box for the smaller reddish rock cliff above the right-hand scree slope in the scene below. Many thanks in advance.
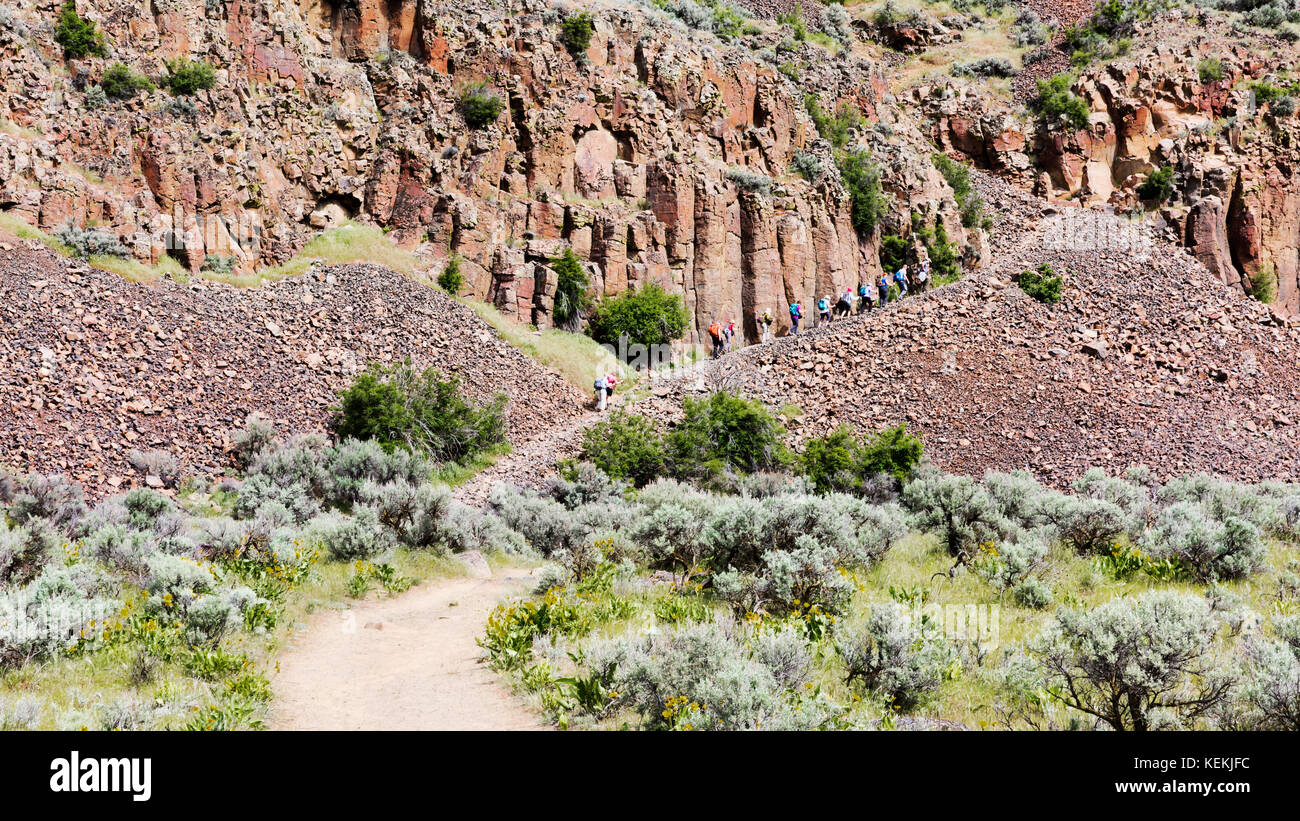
[917,19,1300,314]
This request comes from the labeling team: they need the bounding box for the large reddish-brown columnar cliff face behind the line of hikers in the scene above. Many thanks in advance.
[0,0,978,338]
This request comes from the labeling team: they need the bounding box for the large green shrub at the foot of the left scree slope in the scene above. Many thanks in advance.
[334,360,506,461]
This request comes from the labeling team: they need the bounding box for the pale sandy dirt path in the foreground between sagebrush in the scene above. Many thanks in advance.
[269,568,543,730]
